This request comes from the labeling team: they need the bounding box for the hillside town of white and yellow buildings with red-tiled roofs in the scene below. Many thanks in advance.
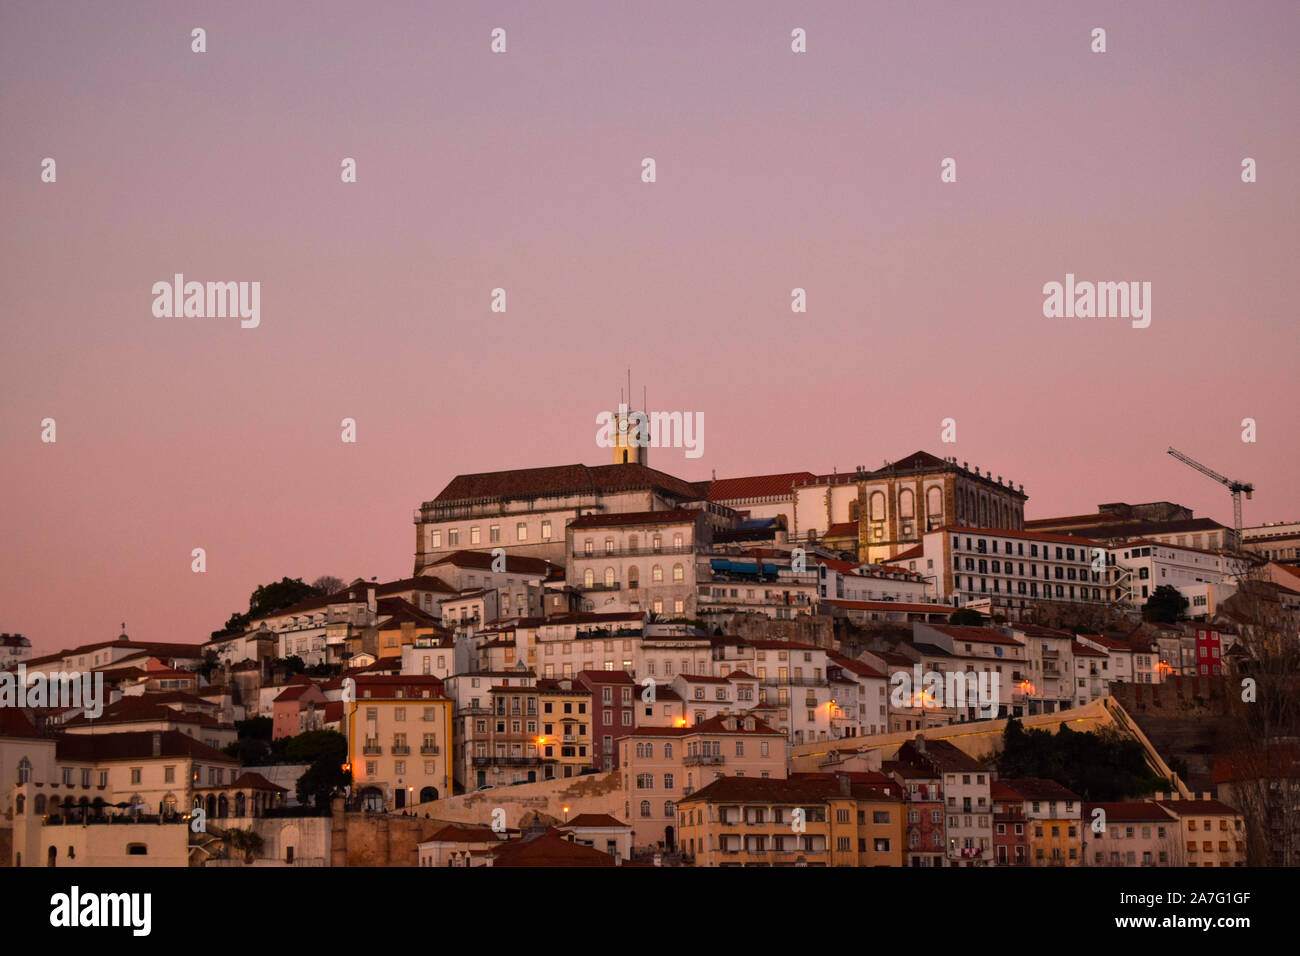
[0,444,1300,868]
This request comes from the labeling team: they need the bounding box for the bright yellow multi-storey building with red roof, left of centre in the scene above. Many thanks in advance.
[343,675,452,810]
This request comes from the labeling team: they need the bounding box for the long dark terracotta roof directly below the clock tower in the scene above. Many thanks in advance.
[429,463,709,503]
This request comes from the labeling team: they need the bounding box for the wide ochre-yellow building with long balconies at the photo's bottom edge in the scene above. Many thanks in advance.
[677,773,905,866]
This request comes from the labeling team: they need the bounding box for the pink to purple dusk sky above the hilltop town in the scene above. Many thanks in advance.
[0,0,1300,650]
